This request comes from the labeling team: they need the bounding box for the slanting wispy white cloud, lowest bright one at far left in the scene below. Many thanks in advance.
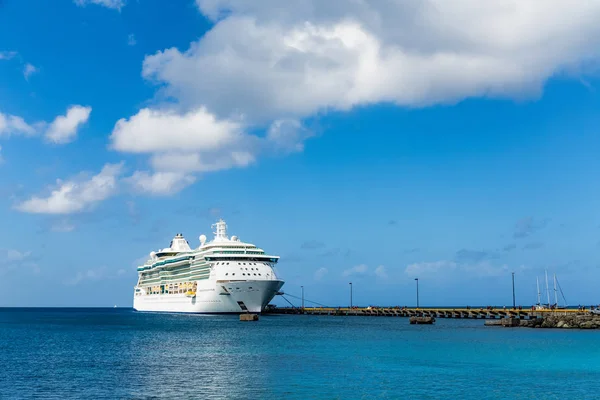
[15,163,123,214]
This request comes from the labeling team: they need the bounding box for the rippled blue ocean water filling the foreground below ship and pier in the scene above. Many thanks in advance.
[0,309,600,399]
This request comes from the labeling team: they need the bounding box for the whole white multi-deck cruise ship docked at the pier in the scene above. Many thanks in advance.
[133,219,284,314]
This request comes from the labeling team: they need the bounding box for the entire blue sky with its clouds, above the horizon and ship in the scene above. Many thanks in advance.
[0,0,600,306]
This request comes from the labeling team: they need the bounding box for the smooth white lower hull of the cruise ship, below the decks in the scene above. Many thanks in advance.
[133,279,283,314]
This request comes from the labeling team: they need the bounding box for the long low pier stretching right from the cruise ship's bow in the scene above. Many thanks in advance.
[263,307,587,319]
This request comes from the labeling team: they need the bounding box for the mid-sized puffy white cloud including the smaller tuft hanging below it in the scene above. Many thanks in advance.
[110,107,262,194]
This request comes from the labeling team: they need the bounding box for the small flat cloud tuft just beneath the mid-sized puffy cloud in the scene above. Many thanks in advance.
[125,171,196,195]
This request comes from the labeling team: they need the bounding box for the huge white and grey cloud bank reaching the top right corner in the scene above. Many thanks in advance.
[143,0,600,122]
